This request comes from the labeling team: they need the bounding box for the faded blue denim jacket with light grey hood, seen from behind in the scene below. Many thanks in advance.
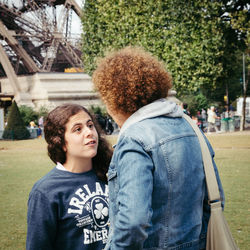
[105,99,224,250]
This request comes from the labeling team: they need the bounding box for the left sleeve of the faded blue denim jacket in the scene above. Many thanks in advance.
[110,138,153,250]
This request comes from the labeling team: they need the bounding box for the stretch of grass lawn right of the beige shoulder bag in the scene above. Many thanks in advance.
[208,131,250,250]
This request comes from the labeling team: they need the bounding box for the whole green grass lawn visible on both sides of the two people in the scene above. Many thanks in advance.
[0,132,250,250]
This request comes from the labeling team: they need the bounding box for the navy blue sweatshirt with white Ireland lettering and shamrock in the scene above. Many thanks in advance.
[26,168,109,250]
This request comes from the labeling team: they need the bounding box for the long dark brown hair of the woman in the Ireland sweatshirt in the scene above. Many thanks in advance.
[44,104,112,182]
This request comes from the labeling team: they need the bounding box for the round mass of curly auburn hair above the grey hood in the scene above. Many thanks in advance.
[92,46,172,114]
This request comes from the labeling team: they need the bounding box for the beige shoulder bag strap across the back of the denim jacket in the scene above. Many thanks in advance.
[183,114,220,203]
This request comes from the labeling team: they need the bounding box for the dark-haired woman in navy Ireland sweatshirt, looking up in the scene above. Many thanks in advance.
[26,104,112,250]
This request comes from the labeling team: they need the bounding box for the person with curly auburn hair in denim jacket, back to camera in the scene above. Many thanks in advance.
[93,47,223,250]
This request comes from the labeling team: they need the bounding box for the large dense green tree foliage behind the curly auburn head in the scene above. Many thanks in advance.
[82,0,248,102]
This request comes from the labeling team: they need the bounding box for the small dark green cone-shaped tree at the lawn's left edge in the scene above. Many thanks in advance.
[3,101,30,140]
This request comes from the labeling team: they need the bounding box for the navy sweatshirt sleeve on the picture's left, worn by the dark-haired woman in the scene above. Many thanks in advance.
[26,191,56,250]
